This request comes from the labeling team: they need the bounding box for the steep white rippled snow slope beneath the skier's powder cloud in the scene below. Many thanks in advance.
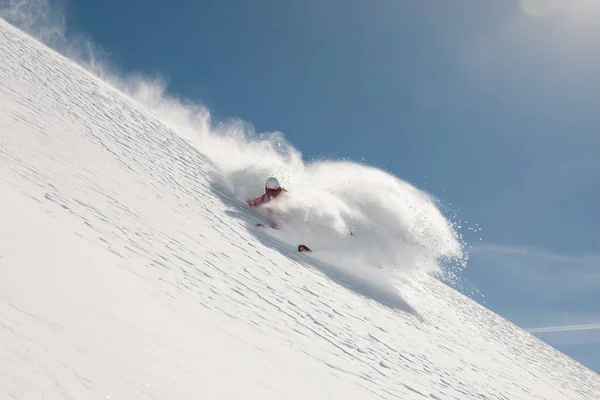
[0,21,600,400]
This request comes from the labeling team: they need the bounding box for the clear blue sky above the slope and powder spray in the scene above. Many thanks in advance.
[5,0,600,371]
